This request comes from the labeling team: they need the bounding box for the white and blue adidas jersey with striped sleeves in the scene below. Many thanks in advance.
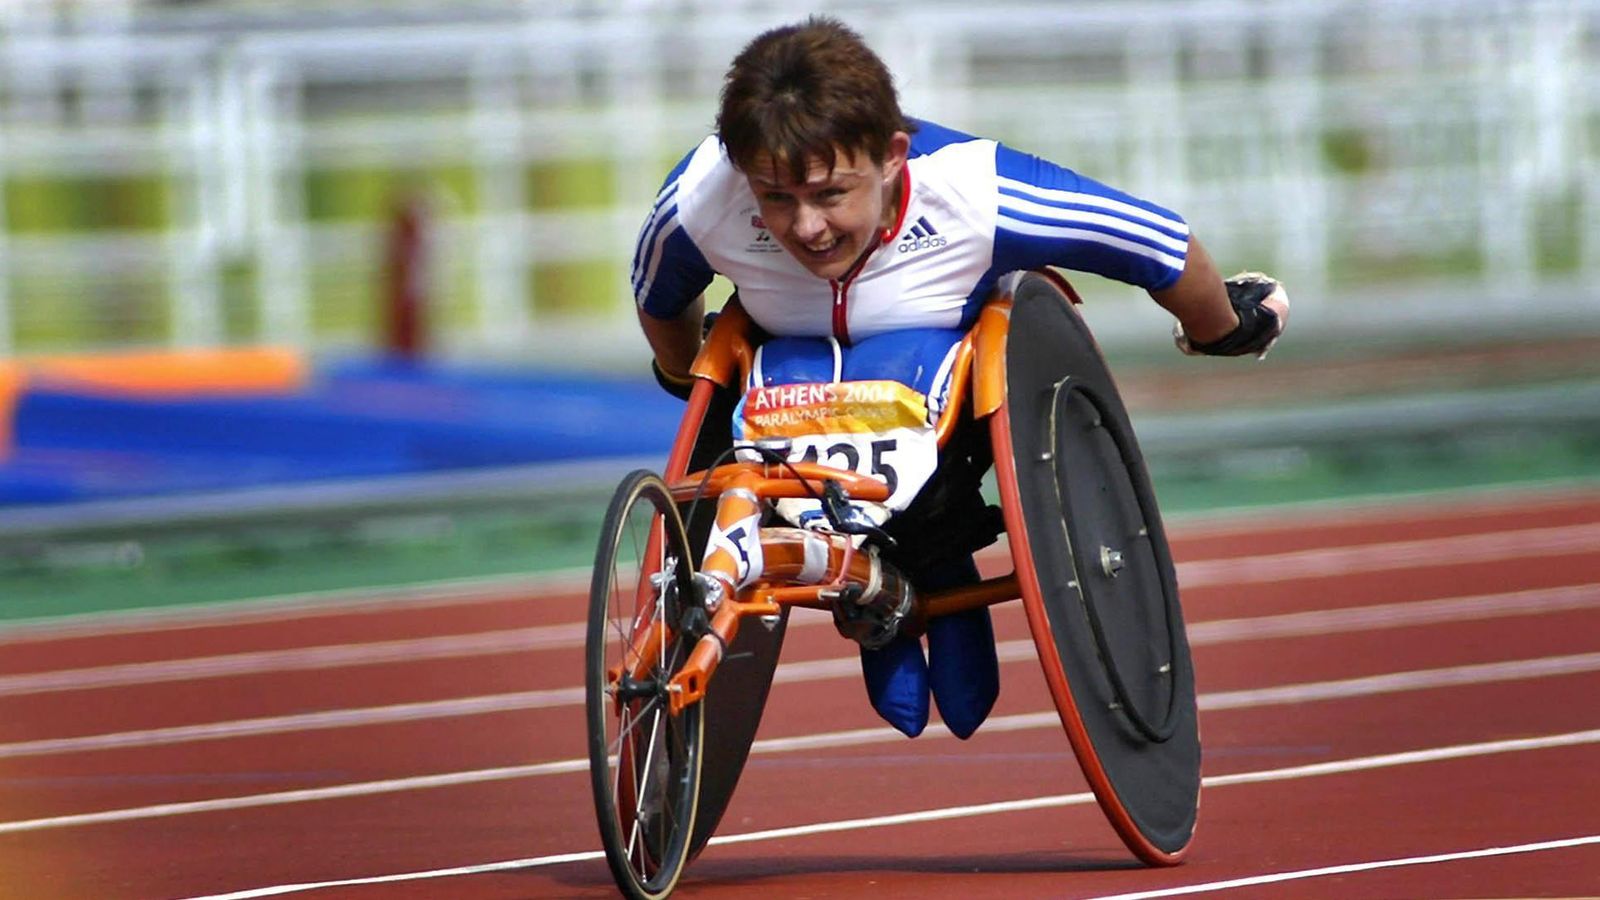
[634,122,1189,346]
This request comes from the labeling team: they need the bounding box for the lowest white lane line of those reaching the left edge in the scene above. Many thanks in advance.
[0,653,1600,834]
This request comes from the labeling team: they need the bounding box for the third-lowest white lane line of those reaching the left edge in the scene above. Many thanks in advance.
[0,564,1600,697]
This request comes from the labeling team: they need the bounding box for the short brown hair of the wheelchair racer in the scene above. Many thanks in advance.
[717,16,914,181]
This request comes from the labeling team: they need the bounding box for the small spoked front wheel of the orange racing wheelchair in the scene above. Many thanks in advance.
[584,469,704,900]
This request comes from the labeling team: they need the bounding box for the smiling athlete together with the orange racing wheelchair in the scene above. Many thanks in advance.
[587,18,1286,897]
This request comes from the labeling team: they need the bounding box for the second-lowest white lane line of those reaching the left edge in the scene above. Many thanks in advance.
[0,585,1600,759]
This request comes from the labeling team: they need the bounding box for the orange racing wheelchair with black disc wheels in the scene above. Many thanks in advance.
[586,272,1200,900]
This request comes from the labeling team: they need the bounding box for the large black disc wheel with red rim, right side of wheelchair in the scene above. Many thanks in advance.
[1000,274,1200,863]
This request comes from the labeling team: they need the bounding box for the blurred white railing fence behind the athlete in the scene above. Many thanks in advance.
[0,0,1600,360]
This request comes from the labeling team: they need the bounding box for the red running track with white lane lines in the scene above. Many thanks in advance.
[0,490,1600,900]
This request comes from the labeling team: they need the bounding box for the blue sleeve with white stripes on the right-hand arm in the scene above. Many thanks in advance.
[995,146,1189,290]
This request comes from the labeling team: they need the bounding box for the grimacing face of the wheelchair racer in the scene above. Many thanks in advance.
[746,133,910,279]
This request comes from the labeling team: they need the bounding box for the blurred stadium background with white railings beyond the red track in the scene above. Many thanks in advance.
[0,0,1600,618]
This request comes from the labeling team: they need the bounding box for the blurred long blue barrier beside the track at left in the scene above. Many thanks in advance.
[0,359,683,504]
